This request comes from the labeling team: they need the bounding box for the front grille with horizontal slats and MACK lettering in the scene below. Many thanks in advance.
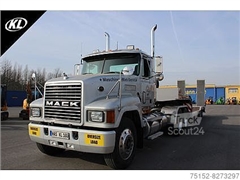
[44,83,82,122]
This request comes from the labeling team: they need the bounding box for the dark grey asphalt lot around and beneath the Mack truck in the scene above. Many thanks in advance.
[1,105,240,170]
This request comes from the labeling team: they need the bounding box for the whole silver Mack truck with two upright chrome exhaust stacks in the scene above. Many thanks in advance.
[28,25,204,169]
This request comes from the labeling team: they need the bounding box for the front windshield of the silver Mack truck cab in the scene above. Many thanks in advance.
[82,53,140,75]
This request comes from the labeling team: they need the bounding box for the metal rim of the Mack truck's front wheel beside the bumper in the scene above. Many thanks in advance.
[119,129,134,160]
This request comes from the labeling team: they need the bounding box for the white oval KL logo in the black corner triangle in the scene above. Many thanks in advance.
[5,17,28,32]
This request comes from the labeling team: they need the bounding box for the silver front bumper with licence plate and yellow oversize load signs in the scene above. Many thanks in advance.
[28,123,116,154]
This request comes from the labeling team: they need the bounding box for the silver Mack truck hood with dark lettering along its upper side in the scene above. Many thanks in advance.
[46,74,140,105]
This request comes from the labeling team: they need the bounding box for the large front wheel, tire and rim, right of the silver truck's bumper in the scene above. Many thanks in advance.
[104,118,137,169]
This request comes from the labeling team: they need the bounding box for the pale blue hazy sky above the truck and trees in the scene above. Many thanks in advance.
[1,10,240,85]
